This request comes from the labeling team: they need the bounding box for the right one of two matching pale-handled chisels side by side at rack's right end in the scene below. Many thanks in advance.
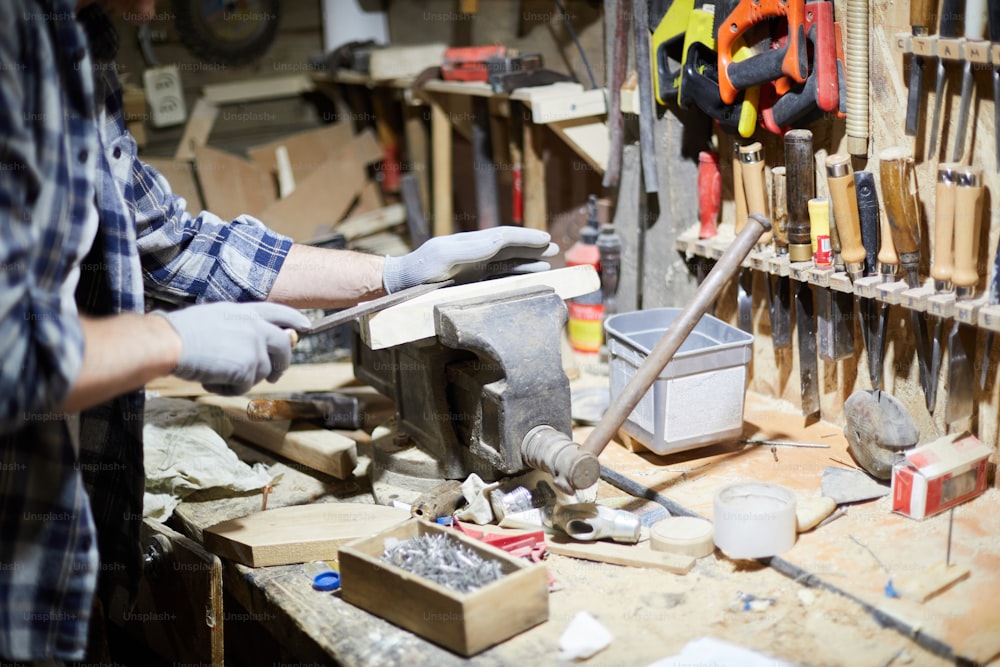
[944,167,983,424]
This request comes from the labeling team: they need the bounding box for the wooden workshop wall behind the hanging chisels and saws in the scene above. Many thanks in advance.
[645,0,1000,456]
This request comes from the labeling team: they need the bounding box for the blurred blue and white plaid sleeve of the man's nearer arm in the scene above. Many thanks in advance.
[0,2,88,433]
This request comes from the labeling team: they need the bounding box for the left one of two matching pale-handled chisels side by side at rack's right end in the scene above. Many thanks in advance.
[927,163,961,413]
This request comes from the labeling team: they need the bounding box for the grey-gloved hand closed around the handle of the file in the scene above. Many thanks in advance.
[157,303,309,396]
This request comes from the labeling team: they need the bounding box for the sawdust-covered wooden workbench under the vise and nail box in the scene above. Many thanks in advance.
[143,362,1000,667]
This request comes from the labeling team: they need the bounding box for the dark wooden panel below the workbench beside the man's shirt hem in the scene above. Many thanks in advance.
[119,519,224,665]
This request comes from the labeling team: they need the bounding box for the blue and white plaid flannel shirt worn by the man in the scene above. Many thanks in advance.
[0,0,291,660]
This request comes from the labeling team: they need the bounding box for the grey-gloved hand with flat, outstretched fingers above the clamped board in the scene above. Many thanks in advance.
[382,226,559,294]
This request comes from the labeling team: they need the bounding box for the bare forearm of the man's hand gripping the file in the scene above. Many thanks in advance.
[60,313,181,412]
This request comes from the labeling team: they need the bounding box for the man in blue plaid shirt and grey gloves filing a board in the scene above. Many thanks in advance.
[0,0,556,661]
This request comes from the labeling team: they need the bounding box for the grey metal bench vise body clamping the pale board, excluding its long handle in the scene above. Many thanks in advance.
[353,287,600,495]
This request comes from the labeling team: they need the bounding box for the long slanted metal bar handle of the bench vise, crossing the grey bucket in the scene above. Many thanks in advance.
[580,213,771,456]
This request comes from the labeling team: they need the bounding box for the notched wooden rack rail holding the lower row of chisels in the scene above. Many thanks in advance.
[677,227,1000,332]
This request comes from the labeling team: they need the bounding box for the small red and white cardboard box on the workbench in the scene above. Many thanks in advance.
[892,433,990,519]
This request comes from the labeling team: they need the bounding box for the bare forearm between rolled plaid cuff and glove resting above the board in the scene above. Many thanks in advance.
[267,244,385,308]
